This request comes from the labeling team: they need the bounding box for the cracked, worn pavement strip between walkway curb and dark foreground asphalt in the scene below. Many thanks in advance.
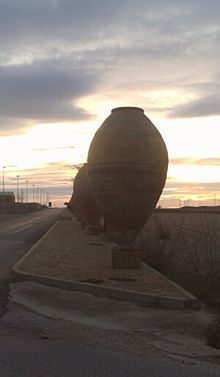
[7,282,220,373]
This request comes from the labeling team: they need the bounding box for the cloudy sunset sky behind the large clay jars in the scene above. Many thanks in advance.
[0,0,220,206]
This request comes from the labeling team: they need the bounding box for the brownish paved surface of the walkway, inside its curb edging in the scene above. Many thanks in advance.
[19,217,195,298]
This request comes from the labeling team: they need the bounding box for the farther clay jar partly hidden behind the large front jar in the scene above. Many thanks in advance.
[73,164,101,225]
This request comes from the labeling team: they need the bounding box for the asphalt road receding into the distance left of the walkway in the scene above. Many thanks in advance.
[0,209,61,281]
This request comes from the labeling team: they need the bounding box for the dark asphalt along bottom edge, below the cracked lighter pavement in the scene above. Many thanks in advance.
[0,328,219,377]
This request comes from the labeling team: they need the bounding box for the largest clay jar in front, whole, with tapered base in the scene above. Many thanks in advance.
[88,107,168,246]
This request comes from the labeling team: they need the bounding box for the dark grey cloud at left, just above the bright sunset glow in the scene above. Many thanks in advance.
[0,57,98,123]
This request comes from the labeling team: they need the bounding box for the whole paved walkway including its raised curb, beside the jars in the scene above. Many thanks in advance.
[14,209,200,309]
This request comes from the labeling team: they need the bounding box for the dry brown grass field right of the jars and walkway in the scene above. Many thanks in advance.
[137,211,220,305]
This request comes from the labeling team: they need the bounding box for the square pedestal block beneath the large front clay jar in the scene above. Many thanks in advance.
[112,247,142,270]
